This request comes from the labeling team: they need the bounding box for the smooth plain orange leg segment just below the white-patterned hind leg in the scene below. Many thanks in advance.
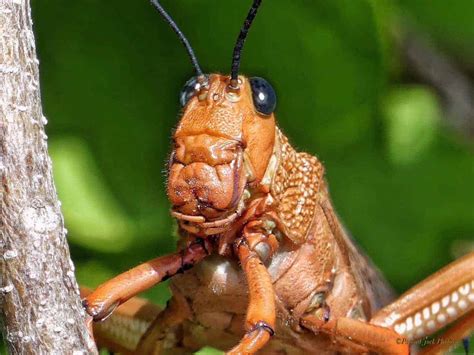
[300,314,409,355]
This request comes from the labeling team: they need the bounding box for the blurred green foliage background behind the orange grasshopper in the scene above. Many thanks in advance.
[25,0,474,354]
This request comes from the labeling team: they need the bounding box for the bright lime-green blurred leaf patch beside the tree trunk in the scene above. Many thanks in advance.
[50,137,135,252]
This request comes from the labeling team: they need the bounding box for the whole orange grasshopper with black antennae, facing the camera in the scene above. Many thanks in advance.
[83,0,474,354]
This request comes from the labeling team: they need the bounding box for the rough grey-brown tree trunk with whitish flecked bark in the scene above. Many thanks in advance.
[0,0,95,354]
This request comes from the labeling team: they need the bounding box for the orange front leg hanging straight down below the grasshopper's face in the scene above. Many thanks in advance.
[227,239,276,355]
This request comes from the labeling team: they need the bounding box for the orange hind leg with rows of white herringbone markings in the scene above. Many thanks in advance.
[370,252,474,340]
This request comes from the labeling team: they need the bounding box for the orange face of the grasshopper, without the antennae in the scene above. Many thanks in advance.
[168,74,275,234]
